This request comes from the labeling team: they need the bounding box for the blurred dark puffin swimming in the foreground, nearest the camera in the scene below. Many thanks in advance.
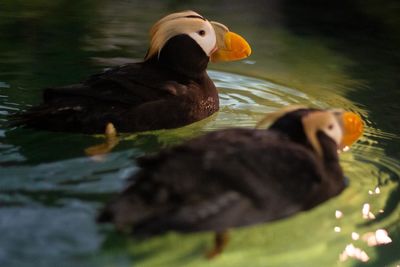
[98,106,363,258]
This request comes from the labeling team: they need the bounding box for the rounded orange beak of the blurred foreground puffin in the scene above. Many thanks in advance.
[340,112,364,149]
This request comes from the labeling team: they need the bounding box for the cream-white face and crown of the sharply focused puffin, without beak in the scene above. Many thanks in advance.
[145,11,217,59]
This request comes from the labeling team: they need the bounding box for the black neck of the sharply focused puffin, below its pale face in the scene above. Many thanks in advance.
[146,34,209,80]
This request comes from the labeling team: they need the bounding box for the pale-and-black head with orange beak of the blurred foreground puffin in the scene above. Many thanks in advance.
[257,106,363,157]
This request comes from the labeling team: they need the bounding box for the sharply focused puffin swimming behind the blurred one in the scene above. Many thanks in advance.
[11,11,251,134]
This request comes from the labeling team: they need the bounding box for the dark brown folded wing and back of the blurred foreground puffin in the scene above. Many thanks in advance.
[100,129,334,234]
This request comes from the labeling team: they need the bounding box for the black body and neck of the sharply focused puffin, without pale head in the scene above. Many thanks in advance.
[13,36,219,133]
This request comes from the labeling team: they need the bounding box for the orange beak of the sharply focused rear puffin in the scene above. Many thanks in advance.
[211,31,251,62]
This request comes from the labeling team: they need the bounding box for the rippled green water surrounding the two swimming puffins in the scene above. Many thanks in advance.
[0,0,400,267]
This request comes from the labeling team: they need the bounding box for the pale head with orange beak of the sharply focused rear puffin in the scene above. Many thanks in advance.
[145,11,251,62]
